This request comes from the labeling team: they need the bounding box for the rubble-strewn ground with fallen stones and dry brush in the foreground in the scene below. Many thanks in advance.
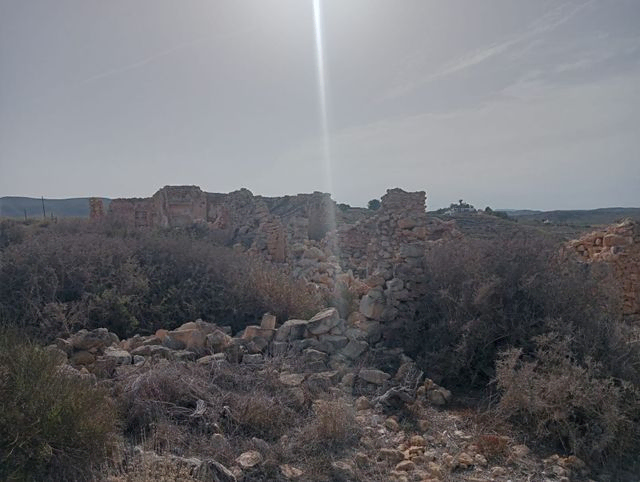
[42,320,604,482]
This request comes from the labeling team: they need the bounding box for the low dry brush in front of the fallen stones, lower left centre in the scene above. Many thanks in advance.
[116,360,306,464]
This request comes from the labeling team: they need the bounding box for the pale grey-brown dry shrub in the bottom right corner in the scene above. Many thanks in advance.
[497,334,640,463]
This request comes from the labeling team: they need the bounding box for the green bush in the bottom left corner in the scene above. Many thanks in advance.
[0,331,117,481]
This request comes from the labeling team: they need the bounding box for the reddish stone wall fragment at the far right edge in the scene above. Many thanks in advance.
[568,220,640,319]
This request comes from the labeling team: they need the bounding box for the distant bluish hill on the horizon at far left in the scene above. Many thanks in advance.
[0,196,111,218]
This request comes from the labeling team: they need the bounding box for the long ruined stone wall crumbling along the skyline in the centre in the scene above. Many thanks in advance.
[109,186,456,333]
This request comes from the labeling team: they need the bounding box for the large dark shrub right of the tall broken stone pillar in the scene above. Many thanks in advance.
[403,233,617,387]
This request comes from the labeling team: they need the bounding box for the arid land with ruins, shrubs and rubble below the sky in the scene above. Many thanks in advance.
[0,186,640,482]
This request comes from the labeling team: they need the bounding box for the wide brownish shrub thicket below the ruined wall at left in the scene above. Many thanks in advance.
[0,222,320,339]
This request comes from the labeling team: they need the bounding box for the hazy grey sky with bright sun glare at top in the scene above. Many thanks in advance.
[0,0,640,210]
